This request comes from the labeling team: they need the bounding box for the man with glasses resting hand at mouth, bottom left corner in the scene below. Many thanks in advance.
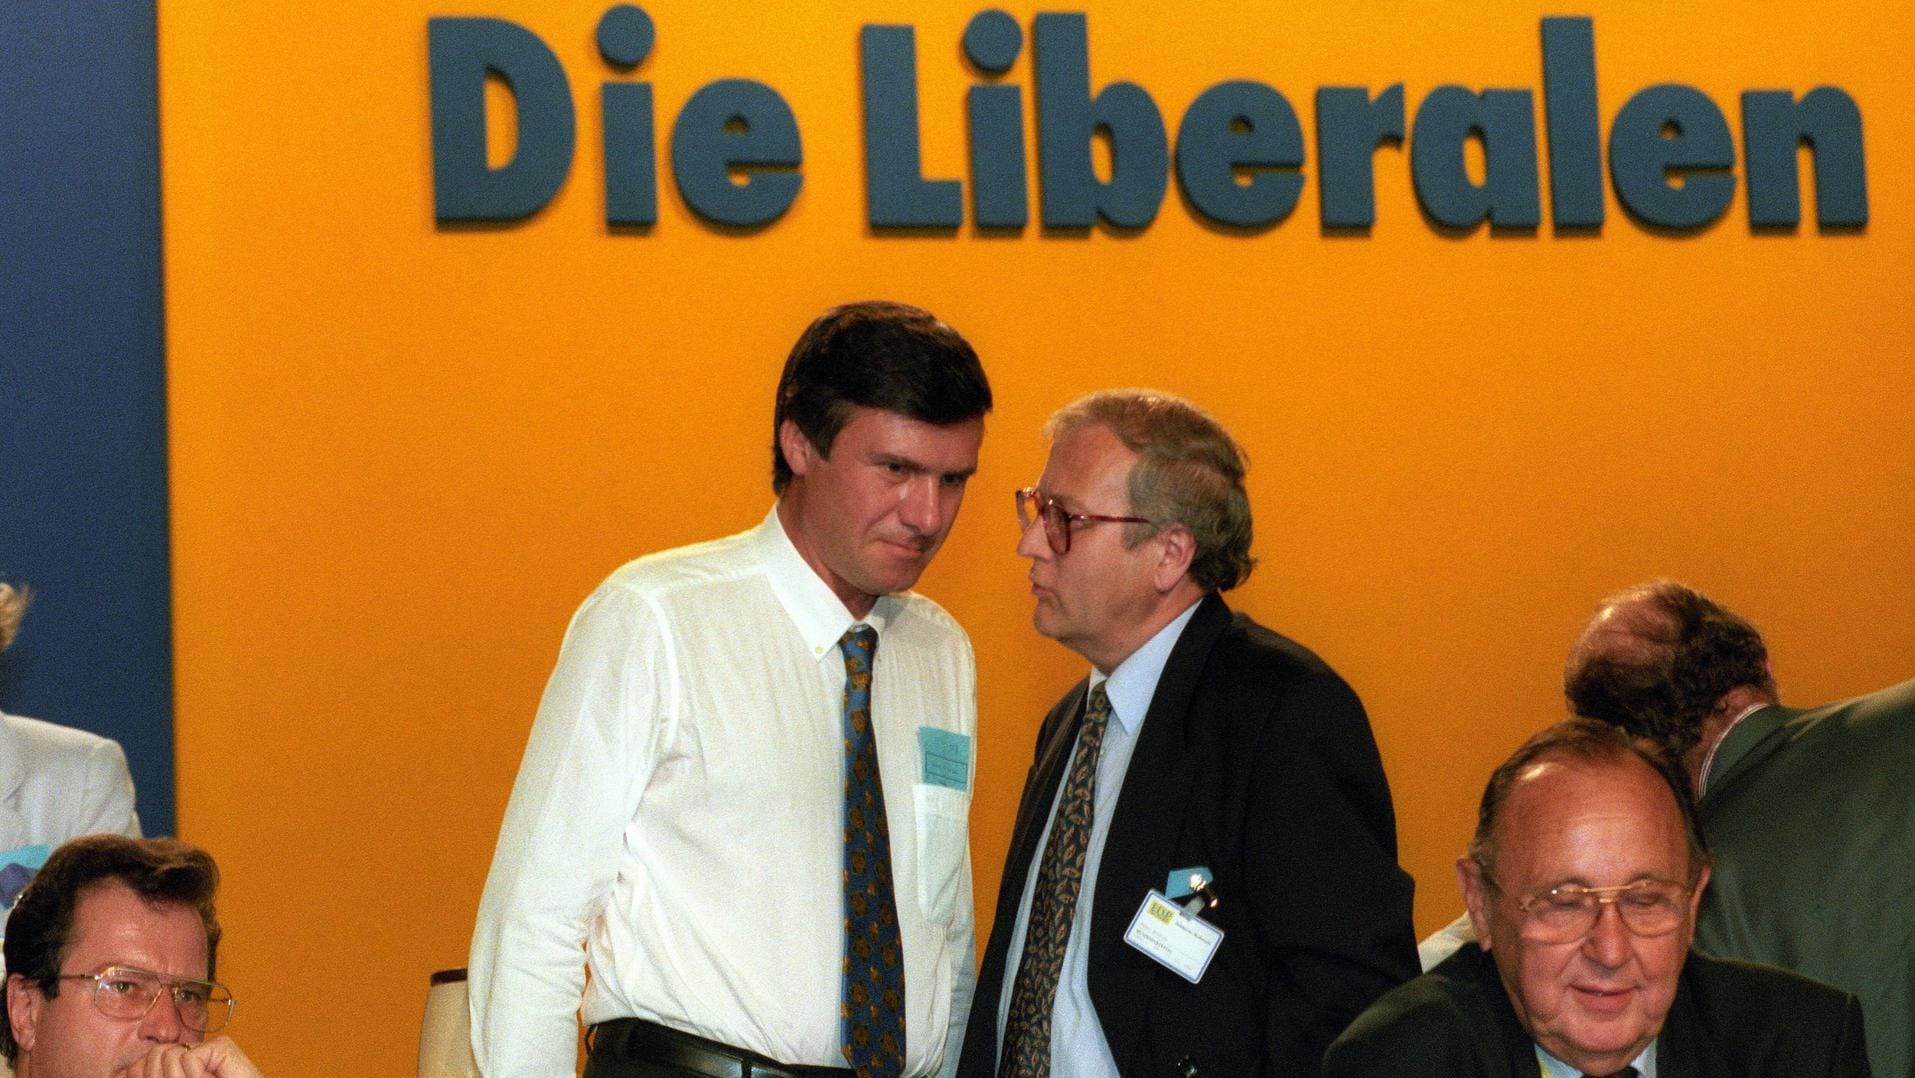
[0,835,260,1078]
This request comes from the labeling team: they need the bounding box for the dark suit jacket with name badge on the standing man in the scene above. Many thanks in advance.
[958,595,1417,1078]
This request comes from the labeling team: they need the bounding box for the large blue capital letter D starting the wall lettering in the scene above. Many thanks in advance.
[425,17,573,220]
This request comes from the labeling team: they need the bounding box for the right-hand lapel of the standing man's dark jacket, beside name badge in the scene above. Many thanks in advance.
[1090,595,1229,1072]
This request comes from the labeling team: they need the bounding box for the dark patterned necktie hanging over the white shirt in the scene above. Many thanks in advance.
[839,624,904,1078]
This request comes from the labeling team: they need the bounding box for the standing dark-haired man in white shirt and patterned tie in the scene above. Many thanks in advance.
[471,303,990,1078]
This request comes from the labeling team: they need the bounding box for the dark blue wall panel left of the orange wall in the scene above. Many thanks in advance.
[0,0,174,835]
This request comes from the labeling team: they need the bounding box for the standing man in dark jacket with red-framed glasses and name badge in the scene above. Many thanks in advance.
[959,391,1415,1078]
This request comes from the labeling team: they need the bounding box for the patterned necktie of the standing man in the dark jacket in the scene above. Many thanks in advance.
[998,684,1111,1078]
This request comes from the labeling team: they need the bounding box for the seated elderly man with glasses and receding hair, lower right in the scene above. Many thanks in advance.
[1323,720,1869,1078]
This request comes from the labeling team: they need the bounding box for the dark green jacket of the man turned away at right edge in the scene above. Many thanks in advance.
[1695,682,1915,1078]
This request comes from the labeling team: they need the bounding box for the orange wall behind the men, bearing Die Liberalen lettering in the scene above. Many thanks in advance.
[159,0,1915,1078]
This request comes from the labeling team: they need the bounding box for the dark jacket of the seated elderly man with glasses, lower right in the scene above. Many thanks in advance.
[1323,944,1869,1078]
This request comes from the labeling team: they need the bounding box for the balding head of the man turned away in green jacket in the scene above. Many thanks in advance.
[1563,580,1775,756]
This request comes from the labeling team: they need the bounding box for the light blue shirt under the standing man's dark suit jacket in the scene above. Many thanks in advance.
[998,603,1197,1078]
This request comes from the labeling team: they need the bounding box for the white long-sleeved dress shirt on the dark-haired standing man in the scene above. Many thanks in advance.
[469,509,977,1078]
